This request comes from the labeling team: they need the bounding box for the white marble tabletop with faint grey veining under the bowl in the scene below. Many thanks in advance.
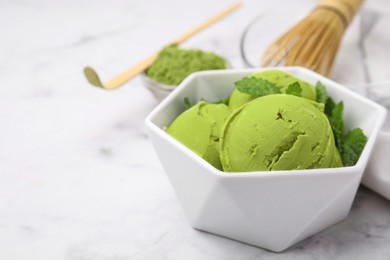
[0,0,390,260]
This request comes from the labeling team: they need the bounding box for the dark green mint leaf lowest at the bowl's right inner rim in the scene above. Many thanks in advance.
[341,128,367,166]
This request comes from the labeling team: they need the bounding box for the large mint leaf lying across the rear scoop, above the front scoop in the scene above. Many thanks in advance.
[234,77,281,97]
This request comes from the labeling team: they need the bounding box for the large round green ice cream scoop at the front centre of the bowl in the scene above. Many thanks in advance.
[220,94,342,172]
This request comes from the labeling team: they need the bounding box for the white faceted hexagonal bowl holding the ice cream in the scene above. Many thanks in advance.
[145,67,386,252]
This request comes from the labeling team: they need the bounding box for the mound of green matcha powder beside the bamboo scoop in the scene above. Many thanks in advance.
[146,45,226,86]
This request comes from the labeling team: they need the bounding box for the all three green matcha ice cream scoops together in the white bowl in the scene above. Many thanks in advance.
[166,70,343,172]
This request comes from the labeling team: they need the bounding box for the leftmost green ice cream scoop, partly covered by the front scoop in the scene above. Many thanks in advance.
[167,101,230,170]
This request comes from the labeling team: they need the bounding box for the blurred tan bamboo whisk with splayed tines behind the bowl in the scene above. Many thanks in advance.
[261,0,364,76]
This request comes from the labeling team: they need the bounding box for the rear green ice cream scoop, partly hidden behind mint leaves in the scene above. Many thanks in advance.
[229,70,317,110]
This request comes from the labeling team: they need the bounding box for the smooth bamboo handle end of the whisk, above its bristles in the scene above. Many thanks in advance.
[317,0,364,26]
